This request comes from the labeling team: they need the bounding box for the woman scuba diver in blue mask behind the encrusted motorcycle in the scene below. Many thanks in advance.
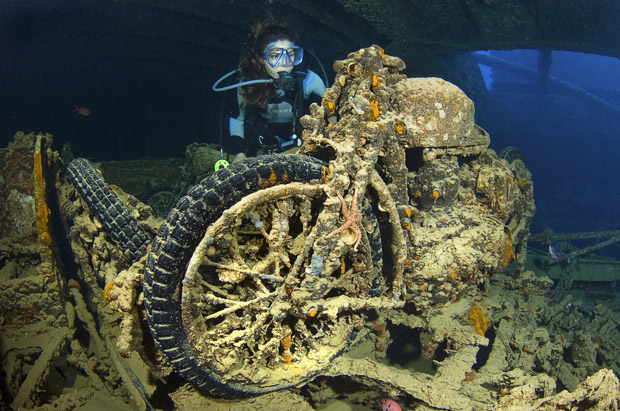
[213,19,325,166]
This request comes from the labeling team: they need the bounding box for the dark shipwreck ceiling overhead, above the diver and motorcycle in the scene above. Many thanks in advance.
[0,0,620,78]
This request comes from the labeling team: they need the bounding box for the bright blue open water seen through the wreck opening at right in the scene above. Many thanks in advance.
[481,50,620,256]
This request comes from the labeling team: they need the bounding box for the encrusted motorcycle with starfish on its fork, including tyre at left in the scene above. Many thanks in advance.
[68,46,534,397]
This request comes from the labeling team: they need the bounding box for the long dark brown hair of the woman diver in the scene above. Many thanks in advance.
[239,17,297,107]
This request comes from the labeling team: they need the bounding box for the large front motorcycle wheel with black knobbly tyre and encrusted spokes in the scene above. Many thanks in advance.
[144,154,382,398]
